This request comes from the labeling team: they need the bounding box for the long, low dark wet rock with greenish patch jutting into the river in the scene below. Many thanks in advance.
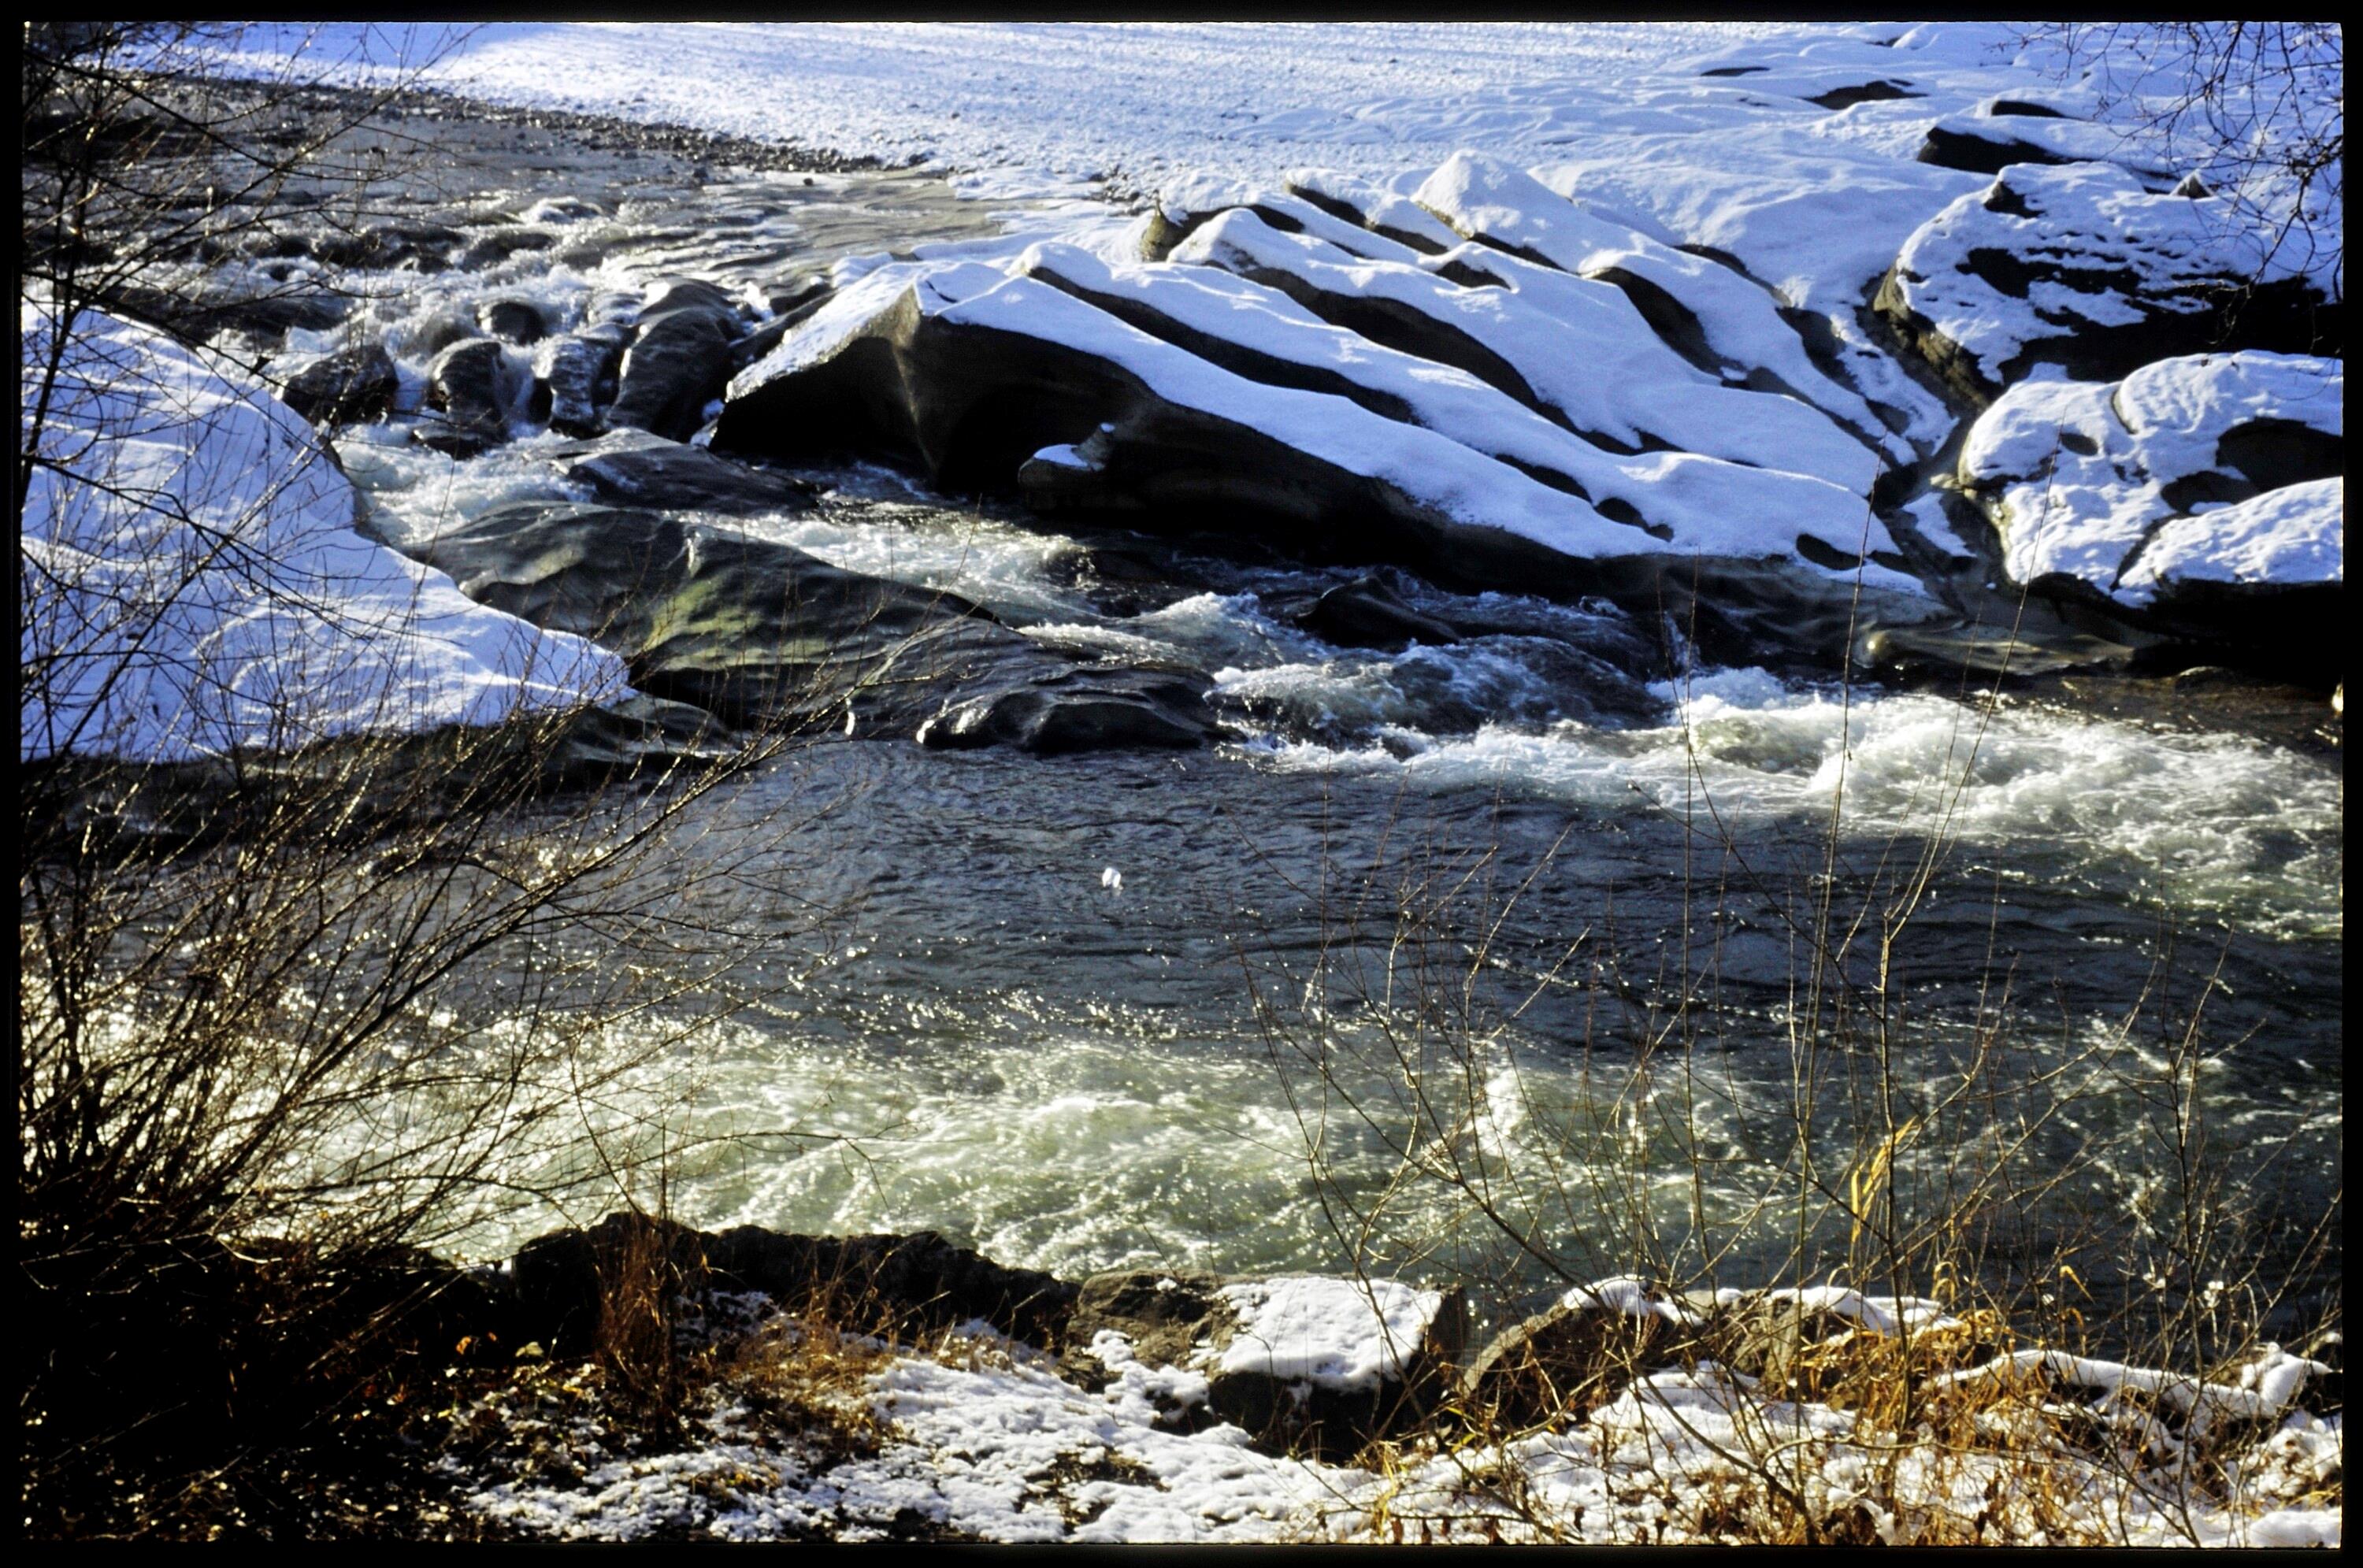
[416,503,1212,754]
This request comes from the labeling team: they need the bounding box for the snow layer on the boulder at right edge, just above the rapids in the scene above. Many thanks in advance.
[1959,352,2346,605]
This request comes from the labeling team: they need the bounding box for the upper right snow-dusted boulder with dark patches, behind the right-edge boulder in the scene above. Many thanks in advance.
[1876,163,2344,406]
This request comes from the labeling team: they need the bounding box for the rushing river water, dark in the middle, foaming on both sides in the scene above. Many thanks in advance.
[272,116,2344,1332]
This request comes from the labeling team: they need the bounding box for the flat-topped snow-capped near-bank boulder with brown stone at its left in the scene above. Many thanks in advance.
[1068,1270,1463,1457]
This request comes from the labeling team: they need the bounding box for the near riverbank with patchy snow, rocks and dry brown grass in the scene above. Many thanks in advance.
[444,1221,2344,1544]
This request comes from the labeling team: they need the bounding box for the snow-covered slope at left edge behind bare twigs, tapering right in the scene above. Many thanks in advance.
[19,305,631,763]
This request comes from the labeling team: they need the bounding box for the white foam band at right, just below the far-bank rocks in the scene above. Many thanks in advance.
[1243,671,2344,937]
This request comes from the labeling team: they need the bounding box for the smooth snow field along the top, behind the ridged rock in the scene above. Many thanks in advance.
[198,21,2337,312]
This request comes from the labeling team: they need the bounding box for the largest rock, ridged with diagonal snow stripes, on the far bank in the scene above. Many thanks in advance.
[711,143,1919,613]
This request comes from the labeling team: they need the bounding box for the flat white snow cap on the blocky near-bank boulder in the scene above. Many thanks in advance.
[1215,1275,1444,1393]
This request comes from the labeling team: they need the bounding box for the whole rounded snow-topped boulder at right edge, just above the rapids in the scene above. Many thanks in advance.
[1957,352,2346,657]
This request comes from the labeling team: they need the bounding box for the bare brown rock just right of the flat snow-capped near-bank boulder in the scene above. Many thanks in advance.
[1456,1301,1701,1431]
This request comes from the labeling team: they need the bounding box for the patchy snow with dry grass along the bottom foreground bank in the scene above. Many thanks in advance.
[456,1280,2344,1544]
